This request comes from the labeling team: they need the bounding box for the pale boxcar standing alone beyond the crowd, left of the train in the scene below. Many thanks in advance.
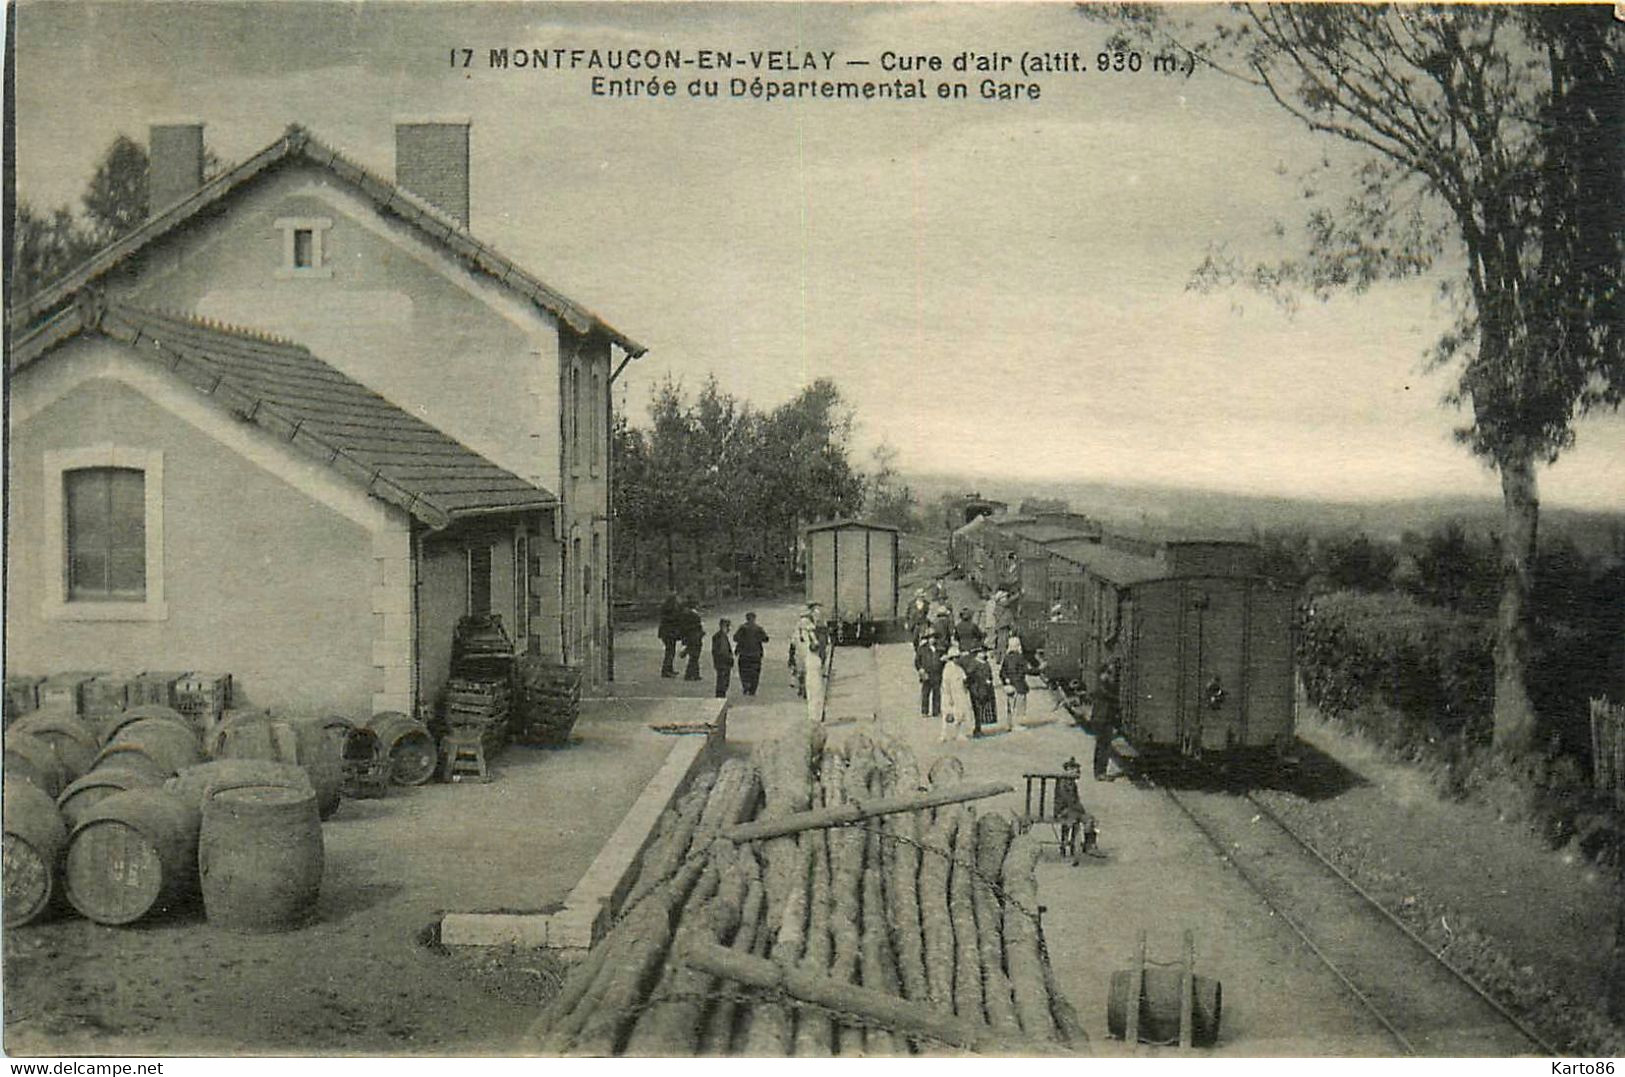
[804,520,899,643]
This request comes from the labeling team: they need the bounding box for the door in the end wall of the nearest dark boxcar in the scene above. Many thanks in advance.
[1180,580,1248,752]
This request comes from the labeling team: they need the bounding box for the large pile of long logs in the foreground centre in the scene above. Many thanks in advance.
[531,723,1087,1056]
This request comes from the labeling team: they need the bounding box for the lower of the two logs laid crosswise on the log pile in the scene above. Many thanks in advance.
[673,942,1058,1056]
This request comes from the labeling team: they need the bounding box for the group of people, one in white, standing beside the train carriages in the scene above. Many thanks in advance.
[908,583,1032,741]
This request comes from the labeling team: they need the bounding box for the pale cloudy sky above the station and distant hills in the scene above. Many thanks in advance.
[15,0,1625,510]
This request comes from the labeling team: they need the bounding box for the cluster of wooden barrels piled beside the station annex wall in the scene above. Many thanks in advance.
[3,705,329,931]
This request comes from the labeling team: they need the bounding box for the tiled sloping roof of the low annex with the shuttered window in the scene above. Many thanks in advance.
[10,292,559,528]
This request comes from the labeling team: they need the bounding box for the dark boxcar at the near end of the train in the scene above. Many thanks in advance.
[1077,534,1297,755]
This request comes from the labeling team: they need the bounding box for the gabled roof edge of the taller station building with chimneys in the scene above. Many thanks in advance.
[11,123,648,357]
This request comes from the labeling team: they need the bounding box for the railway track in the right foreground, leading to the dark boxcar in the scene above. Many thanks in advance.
[1159,785,1558,1058]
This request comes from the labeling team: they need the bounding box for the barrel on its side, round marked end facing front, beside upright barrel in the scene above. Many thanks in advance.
[62,789,200,924]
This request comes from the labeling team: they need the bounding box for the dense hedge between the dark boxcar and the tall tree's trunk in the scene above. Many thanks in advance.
[1298,591,1495,744]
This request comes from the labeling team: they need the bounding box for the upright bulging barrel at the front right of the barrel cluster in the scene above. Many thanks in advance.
[198,783,323,932]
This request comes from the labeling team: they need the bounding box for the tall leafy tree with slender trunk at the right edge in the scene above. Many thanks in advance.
[1105,3,1625,750]
